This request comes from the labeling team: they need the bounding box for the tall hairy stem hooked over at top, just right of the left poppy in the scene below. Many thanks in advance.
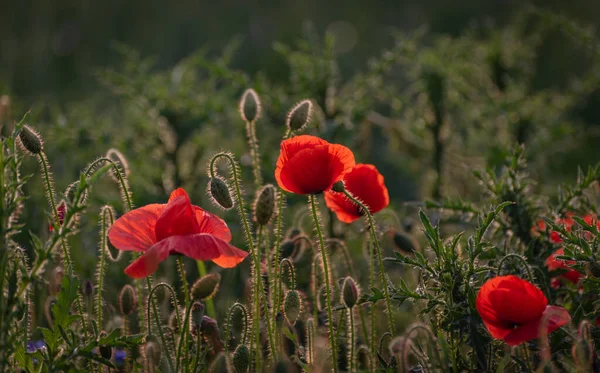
[209,153,277,360]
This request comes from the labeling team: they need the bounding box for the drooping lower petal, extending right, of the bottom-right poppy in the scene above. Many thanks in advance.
[504,306,571,346]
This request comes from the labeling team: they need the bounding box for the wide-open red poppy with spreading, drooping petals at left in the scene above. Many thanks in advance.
[108,188,248,278]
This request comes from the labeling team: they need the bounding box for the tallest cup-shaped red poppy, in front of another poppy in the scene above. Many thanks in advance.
[275,135,355,194]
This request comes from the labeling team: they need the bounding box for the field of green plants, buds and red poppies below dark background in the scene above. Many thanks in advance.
[0,7,600,373]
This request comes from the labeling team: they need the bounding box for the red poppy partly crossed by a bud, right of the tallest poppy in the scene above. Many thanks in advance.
[325,164,390,223]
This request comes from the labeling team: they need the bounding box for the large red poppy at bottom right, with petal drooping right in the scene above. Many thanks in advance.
[476,276,571,346]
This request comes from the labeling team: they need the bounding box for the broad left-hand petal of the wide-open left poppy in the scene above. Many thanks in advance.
[108,203,167,251]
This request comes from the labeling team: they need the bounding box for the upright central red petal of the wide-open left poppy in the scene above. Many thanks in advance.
[155,188,200,241]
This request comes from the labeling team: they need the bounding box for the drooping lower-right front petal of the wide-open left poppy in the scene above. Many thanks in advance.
[164,233,248,268]
